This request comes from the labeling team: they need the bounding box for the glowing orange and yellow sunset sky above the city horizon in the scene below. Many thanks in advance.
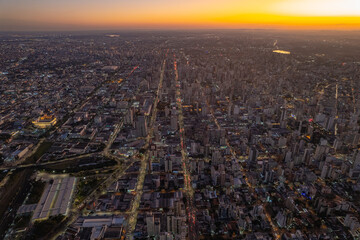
[0,0,360,31]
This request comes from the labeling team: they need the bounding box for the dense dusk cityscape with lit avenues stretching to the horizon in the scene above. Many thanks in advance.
[0,30,360,240]
